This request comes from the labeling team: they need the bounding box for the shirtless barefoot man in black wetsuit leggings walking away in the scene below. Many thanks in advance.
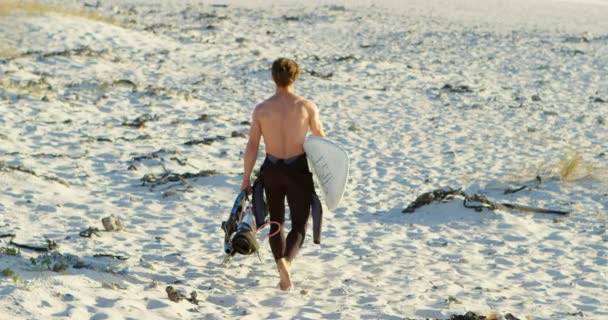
[241,58,325,290]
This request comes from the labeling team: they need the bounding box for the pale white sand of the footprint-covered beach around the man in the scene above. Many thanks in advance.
[0,0,608,319]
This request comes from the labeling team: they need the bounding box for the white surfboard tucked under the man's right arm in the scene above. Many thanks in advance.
[304,136,349,211]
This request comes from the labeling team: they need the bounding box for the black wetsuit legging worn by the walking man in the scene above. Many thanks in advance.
[262,154,314,261]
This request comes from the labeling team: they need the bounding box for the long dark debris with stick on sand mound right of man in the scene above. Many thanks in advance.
[401,188,570,215]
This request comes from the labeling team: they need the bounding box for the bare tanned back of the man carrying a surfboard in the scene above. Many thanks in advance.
[255,94,314,159]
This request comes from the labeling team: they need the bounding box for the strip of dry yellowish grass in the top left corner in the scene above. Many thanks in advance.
[0,1,117,24]
